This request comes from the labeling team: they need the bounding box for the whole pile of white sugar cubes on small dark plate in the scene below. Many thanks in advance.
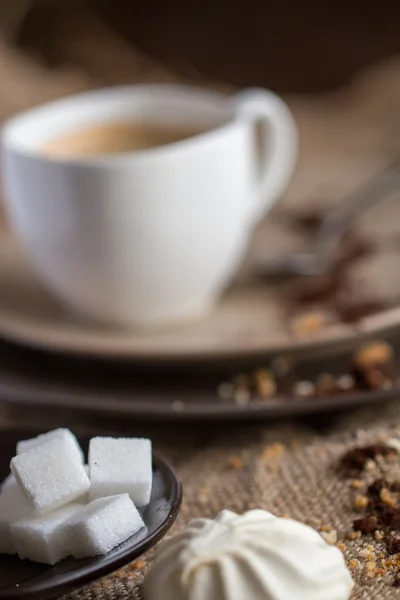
[0,429,152,565]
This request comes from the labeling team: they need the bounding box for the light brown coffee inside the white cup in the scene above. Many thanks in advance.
[41,122,200,158]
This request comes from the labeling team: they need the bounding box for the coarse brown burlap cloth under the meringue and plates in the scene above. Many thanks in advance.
[68,402,400,600]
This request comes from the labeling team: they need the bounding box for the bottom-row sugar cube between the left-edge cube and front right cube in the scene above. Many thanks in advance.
[11,504,82,565]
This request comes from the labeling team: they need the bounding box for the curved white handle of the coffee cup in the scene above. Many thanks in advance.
[234,88,298,227]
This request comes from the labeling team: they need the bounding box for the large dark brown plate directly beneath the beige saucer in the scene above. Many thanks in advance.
[0,336,399,421]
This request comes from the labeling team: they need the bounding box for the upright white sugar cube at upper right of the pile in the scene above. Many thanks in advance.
[89,437,153,506]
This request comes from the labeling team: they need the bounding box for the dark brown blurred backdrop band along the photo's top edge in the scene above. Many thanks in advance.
[0,0,400,93]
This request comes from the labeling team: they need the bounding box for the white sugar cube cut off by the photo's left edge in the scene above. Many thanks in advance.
[0,477,33,554]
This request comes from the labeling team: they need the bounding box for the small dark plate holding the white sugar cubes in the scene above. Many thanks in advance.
[0,431,182,600]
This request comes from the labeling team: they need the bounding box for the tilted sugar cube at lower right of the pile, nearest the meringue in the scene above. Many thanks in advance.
[68,494,144,558]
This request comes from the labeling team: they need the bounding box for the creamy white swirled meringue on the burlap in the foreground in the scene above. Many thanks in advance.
[143,510,353,600]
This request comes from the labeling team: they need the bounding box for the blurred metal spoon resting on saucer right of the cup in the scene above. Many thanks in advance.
[253,161,400,277]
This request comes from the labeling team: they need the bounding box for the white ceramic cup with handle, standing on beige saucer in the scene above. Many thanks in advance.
[2,85,297,327]
